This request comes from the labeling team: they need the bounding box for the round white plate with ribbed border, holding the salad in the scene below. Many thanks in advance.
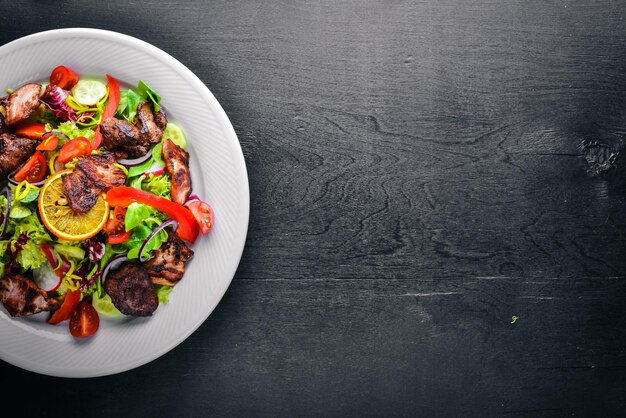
[0,28,250,377]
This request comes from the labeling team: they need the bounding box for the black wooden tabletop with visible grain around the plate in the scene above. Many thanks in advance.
[0,0,626,417]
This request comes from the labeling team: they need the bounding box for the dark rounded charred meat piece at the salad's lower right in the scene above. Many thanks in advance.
[104,262,159,316]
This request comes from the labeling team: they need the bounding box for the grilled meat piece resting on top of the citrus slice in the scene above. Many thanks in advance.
[61,152,126,213]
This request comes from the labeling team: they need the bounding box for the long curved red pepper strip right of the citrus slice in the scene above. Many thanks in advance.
[106,186,200,244]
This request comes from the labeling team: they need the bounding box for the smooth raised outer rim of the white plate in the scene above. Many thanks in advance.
[0,27,250,378]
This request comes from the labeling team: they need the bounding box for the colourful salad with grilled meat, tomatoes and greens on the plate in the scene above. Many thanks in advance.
[0,66,215,338]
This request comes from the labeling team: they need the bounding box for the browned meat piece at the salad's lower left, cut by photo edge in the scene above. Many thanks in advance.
[0,274,61,316]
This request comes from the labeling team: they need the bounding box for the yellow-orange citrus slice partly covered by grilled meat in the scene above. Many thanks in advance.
[38,170,109,241]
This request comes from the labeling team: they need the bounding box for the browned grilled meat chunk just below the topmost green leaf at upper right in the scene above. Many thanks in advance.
[100,102,167,158]
